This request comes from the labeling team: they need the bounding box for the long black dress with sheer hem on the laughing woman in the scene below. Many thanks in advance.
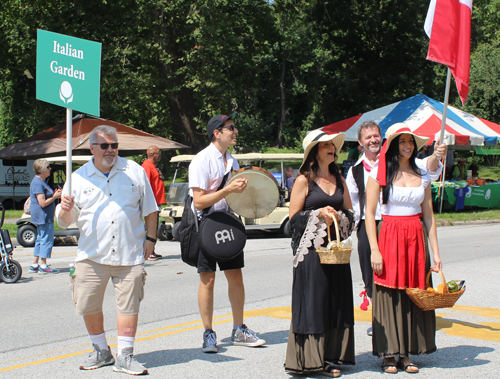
[285,182,355,373]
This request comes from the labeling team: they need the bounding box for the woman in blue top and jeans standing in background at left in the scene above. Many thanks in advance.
[30,159,62,274]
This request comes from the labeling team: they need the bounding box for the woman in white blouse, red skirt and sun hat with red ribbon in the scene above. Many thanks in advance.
[365,123,442,373]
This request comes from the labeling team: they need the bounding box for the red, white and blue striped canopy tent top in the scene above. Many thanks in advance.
[322,95,500,147]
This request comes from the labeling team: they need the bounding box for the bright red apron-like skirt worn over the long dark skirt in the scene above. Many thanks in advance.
[373,213,427,289]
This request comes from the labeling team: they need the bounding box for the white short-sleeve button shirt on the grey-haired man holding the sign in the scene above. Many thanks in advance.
[56,157,158,266]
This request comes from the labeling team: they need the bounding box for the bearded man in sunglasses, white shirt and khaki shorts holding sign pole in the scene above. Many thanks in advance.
[56,125,158,375]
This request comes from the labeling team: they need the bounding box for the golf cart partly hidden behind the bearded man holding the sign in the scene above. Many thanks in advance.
[16,155,92,247]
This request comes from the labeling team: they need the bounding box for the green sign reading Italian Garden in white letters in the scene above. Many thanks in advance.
[36,29,101,116]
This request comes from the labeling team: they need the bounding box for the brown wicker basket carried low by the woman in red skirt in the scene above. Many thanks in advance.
[406,271,465,311]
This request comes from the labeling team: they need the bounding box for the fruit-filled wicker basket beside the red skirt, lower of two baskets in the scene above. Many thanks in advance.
[406,271,465,311]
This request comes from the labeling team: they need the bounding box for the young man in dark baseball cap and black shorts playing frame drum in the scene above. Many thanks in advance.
[189,113,266,353]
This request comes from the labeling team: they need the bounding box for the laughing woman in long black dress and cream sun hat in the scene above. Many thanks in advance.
[285,130,354,377]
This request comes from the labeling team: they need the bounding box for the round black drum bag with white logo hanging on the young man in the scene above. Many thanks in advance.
[198,212,247,262]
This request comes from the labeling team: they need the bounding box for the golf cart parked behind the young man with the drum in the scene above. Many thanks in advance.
[159,153,303,240]
